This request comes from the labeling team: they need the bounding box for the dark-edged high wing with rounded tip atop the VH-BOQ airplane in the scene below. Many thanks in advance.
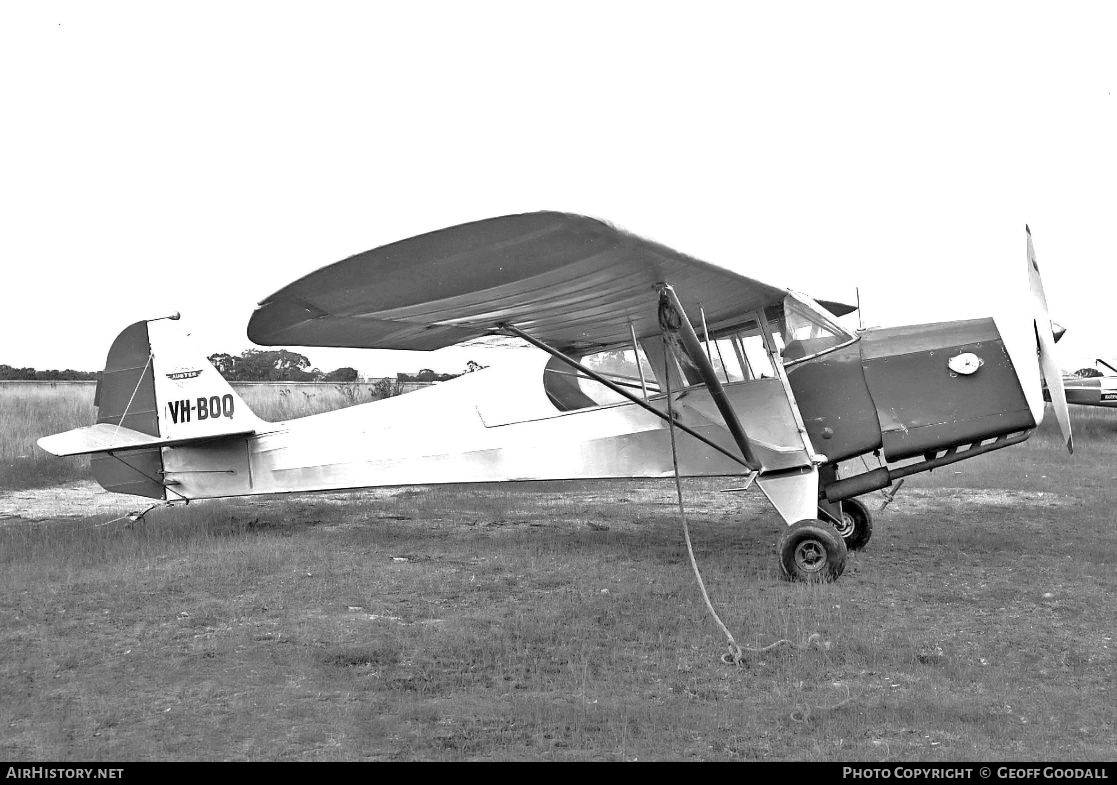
[248,212,852,350]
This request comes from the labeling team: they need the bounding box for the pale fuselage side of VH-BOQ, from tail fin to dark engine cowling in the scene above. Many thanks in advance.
[163,354,803,500]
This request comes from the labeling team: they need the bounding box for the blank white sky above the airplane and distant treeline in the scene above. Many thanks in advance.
[0,0,1117,375]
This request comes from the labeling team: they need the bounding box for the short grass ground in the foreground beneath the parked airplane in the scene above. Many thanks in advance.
[0,386,1117,762]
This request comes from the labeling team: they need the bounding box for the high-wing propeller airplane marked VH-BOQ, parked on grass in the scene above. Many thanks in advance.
[39,212,1071,580]
